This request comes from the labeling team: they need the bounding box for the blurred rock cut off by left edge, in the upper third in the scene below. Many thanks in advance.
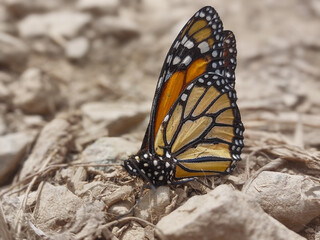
[0,32,29,69]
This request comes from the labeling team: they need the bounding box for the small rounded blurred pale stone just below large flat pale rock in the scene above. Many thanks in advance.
[65,37,89,60]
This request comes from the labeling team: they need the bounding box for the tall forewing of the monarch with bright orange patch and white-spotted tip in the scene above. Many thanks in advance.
[142,7,229,153]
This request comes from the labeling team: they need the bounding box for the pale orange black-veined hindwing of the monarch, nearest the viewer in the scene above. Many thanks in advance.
[154,73,244,178]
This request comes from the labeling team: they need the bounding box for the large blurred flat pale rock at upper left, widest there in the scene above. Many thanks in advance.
[18,11,91,38]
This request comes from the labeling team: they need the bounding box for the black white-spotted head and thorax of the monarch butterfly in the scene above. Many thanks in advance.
[123,152,175,186]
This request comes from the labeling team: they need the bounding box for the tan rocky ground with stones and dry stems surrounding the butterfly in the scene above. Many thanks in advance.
[0,0,320,240]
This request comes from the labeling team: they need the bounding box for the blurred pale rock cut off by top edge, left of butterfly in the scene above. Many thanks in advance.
[77,0,120,14]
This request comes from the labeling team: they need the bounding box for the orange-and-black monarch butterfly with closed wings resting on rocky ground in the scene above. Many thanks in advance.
[123,6,244,186]
